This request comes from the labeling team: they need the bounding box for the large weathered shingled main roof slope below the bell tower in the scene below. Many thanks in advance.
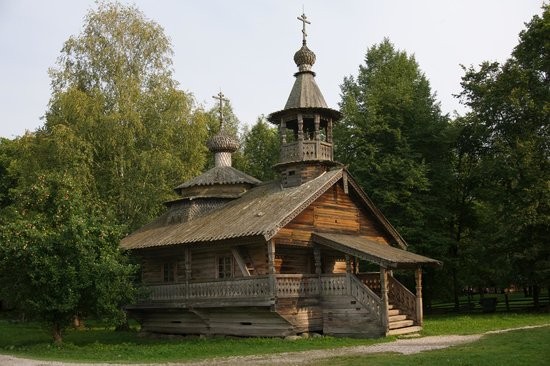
[121,168,343,249]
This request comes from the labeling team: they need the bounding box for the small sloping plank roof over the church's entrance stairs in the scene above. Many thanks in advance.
[312,233,442,268]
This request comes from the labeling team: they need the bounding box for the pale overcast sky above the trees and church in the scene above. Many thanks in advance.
[0,0,544,138]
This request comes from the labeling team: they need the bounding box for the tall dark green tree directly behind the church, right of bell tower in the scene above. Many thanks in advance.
[335,39,447,226]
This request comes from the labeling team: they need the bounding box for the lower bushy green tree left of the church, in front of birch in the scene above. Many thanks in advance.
[0,128,135,342]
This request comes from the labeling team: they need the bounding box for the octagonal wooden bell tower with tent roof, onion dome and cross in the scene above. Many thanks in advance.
[268,14,341,187]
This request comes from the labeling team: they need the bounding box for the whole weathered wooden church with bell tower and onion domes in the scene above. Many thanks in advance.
[121,15,440,337]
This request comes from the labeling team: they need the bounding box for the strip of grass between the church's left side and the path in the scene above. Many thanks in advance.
[0,320,392,363]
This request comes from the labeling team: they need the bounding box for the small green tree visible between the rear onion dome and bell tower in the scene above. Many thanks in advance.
[242,116,280,181]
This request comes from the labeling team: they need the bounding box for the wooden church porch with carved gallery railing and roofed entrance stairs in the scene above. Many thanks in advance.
[135,234,440,336]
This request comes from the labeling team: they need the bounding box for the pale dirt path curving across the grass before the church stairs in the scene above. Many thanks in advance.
[0,324,550,366]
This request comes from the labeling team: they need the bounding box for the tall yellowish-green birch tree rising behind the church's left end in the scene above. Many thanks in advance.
[44,2,208,230]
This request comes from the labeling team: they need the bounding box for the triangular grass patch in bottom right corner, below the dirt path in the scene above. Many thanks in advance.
[311,327,550,366]
